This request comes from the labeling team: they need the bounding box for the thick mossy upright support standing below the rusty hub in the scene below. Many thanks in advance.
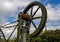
[17,13,30,42]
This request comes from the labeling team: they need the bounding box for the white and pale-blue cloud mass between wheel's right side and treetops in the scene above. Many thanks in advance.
[46,4,60,30]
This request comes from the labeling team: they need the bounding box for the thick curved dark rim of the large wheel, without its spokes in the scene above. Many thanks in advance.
[23,1,47,37]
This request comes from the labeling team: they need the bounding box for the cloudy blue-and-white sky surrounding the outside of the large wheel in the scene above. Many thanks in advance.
[0,0,60,36]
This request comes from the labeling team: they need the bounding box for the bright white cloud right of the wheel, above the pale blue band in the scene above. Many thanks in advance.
[47,4,60,21]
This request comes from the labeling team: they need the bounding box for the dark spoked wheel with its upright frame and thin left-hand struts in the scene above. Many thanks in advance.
[0,1,47,42]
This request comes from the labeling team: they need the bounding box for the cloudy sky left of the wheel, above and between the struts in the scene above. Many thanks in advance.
[0,0,39,37]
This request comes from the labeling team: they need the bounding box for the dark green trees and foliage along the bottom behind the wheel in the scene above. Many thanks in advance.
[0,30,60,42]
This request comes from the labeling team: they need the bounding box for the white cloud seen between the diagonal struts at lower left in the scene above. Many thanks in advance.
[2,28,17,39]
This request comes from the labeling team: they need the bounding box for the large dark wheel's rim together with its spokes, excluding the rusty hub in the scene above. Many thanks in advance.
[23,1,47,37]
